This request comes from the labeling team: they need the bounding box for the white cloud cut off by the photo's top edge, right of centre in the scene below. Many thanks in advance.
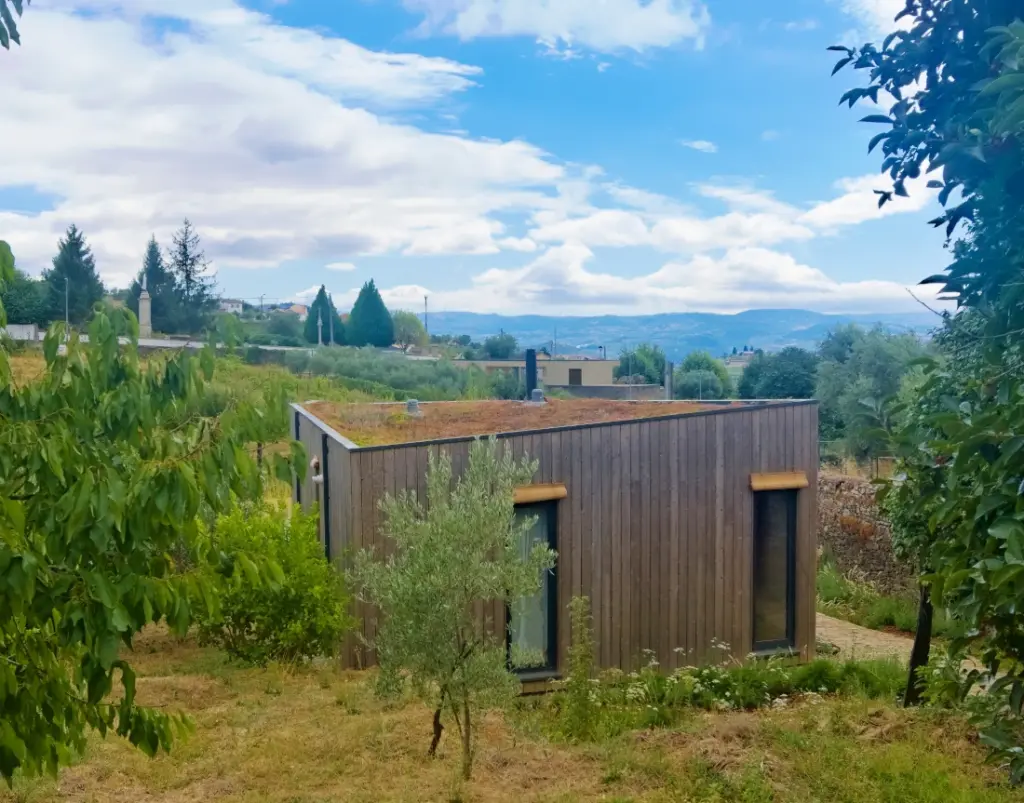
[404,0,711,52]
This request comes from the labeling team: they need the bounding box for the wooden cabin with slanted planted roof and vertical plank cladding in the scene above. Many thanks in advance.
[293,399,818,680]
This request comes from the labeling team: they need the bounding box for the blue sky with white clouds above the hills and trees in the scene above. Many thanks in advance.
[0,0,946,315]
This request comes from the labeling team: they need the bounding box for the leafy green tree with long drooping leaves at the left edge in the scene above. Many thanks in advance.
[0,297,304,780]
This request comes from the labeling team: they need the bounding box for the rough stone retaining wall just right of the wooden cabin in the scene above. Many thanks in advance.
[818,474,913,593]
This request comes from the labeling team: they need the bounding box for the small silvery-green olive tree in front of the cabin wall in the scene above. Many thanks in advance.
[355,438,555,778]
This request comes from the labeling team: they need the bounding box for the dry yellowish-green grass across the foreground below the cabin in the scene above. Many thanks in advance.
[0,632,1021,803]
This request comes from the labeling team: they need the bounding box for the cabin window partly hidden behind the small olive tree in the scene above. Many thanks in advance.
[507,502,558,675]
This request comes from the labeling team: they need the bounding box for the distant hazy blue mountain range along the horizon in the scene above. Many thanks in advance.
[428,309,938,360]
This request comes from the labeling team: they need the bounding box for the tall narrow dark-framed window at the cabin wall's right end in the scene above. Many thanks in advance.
[754,491,797,650]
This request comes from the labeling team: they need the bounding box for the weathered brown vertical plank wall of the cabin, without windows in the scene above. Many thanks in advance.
[300,403,818,669]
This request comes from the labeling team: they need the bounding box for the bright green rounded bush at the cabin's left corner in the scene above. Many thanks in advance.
[199,504,352,666]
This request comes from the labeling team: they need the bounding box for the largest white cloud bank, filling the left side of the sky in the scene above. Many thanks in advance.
[0,0,571,276]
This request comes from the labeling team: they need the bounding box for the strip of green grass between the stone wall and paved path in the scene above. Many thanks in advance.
[817,560,961,638]
